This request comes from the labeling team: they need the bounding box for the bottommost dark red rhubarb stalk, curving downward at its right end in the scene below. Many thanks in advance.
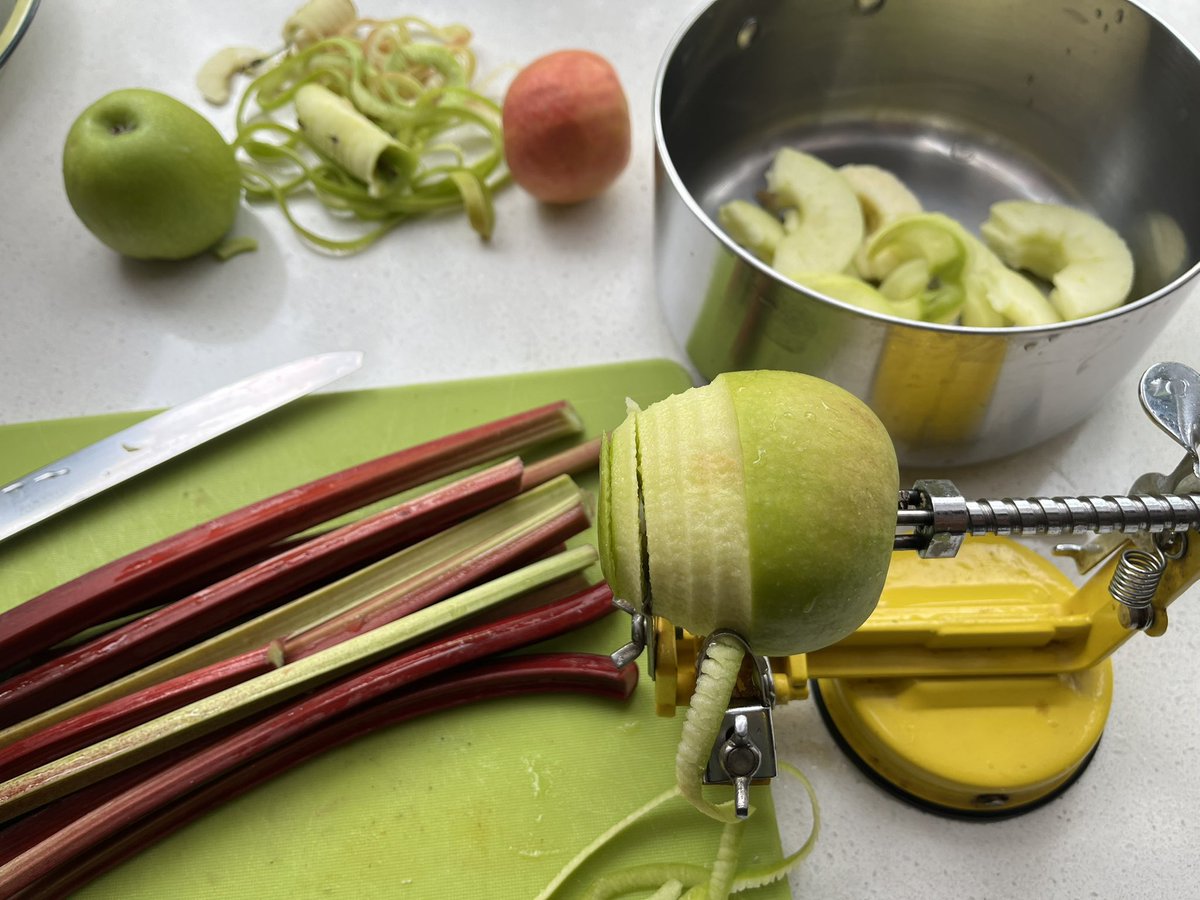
[7,653,637,900]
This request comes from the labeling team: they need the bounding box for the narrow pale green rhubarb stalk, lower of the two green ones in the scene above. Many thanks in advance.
[0,545,596,822]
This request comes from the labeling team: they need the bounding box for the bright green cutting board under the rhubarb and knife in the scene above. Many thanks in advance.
[0,361,788,900]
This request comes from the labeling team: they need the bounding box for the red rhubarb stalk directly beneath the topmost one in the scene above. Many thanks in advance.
[0,460,523,727]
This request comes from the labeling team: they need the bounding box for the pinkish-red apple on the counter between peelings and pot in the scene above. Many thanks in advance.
[503,50,630,203]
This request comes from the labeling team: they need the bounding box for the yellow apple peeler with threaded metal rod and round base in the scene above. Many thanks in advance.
[613,362,1200,818]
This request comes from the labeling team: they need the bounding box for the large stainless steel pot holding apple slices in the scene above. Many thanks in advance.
[655,0,1200,466]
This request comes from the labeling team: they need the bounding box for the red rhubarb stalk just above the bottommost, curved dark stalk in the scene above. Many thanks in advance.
[0,583,612,896]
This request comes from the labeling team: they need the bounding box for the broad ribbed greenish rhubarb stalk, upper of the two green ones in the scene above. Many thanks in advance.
[0,475,582,748]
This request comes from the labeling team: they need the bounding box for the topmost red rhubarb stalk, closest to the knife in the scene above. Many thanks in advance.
[0,402,581,668]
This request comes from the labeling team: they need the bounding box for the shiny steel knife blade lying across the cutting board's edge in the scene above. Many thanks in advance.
[0,350,362,541]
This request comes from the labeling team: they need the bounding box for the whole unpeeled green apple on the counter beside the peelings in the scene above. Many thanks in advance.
[62,89,241,259]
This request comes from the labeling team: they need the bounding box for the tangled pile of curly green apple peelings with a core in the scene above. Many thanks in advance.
[208,7,510,253]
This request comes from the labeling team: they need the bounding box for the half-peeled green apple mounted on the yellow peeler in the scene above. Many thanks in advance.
[599,371,899,655]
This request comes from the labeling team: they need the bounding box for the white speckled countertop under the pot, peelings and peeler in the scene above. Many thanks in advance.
[0,0,1200,900]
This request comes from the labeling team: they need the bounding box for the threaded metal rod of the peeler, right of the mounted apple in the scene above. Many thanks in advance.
[894,479,1200,558]
